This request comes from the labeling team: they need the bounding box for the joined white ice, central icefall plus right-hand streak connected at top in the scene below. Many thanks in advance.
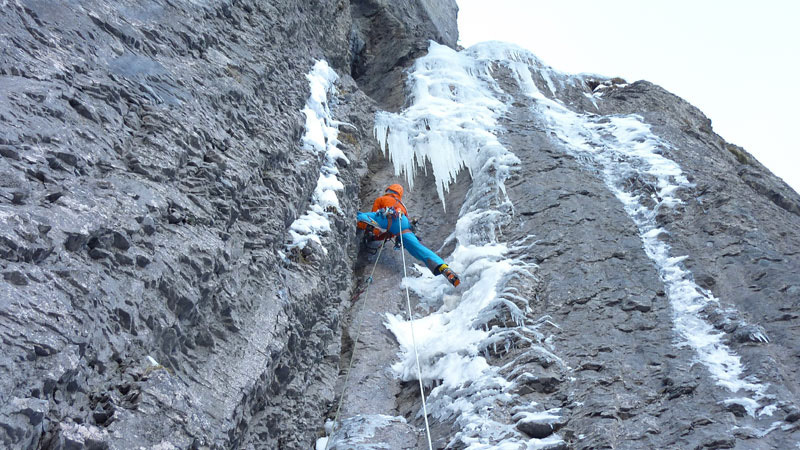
[375,43,769,449]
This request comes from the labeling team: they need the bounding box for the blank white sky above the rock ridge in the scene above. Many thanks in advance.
[457,0,800,192]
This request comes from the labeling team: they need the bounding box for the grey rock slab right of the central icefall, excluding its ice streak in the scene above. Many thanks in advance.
[503,72,800,448]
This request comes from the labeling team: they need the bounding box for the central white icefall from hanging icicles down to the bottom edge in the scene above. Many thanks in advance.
[375,43,562,450]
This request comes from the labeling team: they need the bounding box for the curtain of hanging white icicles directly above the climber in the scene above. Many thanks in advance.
[375,42,505,209]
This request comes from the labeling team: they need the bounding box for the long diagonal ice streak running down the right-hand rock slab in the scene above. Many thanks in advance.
[498,44,766,404]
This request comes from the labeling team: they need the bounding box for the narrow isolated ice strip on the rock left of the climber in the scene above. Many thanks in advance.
[289,60,347,253]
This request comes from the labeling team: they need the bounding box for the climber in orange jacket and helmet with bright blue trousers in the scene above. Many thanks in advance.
[358,184,461,286]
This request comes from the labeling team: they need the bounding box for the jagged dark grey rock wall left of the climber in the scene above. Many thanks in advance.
[0,0,455,448]
